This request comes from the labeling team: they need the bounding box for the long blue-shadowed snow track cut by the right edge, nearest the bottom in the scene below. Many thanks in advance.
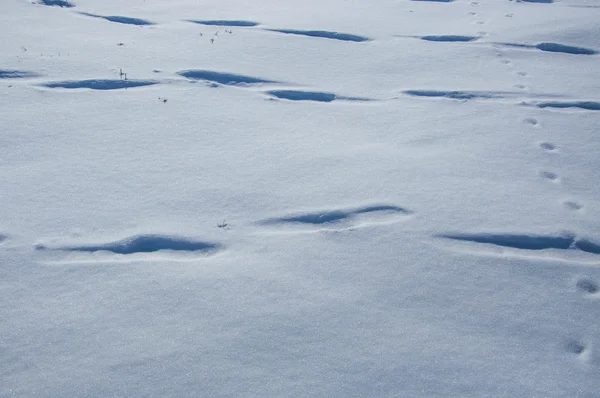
[440,233,600,254]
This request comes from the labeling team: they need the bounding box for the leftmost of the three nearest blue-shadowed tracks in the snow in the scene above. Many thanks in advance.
[35,235,221,254]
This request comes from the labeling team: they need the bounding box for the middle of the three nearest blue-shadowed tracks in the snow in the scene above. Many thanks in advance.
[260,205,411,226]
